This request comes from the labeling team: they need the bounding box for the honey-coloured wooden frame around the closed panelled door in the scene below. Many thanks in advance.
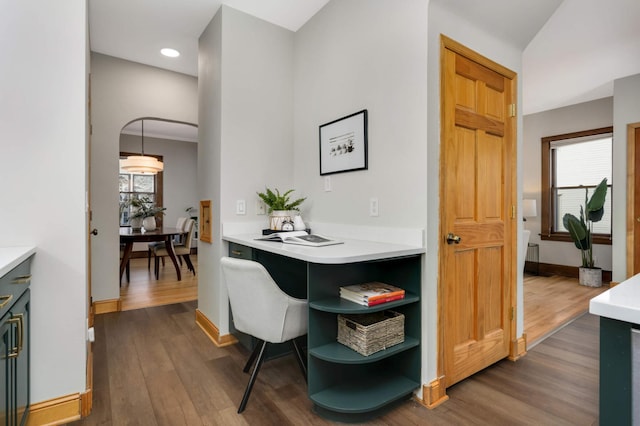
[431,34,526,390]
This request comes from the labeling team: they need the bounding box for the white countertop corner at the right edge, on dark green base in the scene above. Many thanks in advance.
[589,274,640,324]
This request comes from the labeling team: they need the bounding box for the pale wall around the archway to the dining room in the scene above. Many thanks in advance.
[91,53,198,301]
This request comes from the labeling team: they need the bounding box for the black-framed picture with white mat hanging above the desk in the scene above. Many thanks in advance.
[320,109,368,176]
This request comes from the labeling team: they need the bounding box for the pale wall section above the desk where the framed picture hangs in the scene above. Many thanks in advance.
[294,0,427,228]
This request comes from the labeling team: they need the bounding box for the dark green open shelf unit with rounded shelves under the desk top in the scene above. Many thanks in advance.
[308,256,421,422]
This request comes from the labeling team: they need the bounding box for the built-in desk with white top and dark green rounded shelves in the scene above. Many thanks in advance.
[223,234,425,423]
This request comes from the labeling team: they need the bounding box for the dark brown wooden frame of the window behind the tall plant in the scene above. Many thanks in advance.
[540,126,613,245]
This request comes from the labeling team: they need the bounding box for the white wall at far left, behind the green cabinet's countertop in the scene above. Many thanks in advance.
[0,0,88,402]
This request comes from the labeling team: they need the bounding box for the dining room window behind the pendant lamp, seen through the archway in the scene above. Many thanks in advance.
[118,152,163,226]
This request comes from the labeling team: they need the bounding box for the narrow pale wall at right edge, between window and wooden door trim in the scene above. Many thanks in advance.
[612,74,640,281]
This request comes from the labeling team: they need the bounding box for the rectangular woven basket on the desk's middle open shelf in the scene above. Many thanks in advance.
[338,311,404,356]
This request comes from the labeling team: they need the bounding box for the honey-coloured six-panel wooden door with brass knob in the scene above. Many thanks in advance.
[439,37,517,387]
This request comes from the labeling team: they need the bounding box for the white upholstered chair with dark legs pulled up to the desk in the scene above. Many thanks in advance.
[220,257,308,413]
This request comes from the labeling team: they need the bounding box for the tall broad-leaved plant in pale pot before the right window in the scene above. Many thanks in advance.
[562,178,607,287]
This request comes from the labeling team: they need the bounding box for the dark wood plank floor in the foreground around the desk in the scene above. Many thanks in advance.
[74,302,598,426]
